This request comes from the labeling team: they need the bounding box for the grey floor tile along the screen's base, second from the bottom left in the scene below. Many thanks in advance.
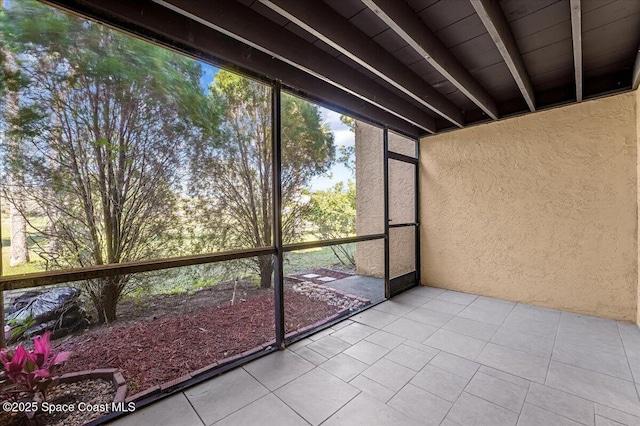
[184,368,273,425]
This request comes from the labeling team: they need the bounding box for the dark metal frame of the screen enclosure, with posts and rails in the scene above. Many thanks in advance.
[0,0,419,425]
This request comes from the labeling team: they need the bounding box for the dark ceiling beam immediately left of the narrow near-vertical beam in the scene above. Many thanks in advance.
[470,0,536,111]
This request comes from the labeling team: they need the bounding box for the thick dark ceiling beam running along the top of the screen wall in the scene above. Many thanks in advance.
[46,0,424,136]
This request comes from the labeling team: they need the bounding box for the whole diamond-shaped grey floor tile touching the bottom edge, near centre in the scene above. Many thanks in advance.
[275,368,360,425]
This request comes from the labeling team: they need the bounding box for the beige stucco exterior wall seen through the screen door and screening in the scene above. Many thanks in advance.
[355,122,415,277]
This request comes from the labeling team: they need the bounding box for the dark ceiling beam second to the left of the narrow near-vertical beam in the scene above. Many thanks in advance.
[362,0,498,120]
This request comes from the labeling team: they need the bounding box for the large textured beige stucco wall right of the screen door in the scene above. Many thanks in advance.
[420,93,639,321]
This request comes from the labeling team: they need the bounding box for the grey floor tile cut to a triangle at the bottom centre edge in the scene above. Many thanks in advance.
[322,393,421,426]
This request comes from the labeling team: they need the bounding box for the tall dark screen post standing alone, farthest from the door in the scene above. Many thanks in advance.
[271,80,284,349]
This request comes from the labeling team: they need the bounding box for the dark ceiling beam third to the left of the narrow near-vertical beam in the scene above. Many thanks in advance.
[259,0,464,127]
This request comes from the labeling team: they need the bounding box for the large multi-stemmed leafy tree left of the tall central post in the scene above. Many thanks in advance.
[0,0,217,323]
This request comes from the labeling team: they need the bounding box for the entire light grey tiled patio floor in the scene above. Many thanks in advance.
[112,287,640,426]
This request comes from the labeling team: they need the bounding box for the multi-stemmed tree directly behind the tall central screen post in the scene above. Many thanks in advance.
[191,71,335,288]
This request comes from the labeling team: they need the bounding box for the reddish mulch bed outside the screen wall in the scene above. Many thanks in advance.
[57,290,338,395]
